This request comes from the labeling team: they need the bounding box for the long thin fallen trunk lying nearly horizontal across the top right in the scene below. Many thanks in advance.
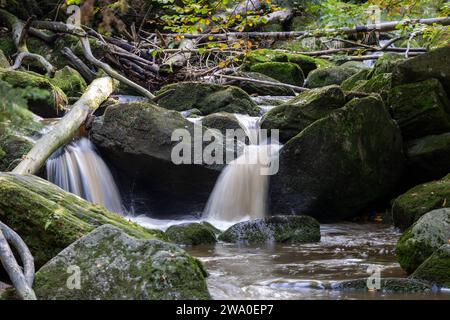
[154,17,450,41]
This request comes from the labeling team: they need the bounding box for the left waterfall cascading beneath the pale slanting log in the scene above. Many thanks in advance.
[46,138,123,213]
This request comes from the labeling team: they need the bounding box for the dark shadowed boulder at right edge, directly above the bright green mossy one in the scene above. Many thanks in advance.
[405,132,450,183]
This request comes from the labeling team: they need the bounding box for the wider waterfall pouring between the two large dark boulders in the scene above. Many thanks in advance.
[203,114,279,221]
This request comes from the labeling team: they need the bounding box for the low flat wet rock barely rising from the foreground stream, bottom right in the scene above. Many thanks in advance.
[331,277,432,293]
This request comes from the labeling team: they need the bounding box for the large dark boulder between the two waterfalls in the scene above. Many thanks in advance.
[91,102,239,218]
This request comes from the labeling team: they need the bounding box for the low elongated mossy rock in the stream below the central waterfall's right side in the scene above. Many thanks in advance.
[219,215,320,243]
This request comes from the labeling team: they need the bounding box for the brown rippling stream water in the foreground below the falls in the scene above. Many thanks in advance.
[186,223,450,300]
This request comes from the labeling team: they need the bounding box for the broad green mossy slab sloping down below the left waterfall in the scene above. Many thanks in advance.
[0,173,161,267]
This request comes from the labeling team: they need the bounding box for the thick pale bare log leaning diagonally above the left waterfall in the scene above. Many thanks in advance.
[12,77,114,174]
